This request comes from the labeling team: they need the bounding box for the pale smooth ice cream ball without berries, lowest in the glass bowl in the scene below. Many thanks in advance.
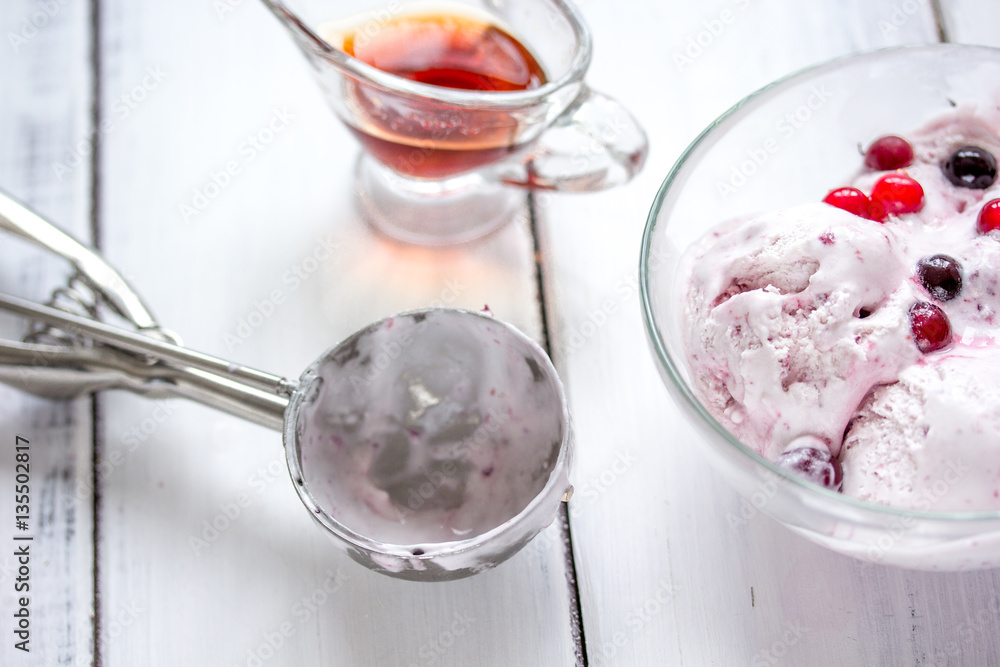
[841,347,1000,511]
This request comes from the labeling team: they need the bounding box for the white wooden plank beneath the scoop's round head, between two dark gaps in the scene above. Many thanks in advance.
[94,1,573,667]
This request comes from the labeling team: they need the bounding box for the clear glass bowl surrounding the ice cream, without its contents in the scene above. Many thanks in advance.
[640,44,1000,570]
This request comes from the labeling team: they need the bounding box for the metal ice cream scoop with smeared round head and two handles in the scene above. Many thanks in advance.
[0,190,572,581]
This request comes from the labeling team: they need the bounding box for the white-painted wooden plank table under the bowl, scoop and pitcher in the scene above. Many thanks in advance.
[0,0,1000,667]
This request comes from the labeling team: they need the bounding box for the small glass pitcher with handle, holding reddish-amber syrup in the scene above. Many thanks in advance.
[263,0,647,244]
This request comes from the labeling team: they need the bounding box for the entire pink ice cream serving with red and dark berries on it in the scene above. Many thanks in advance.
[680,108,1000,511]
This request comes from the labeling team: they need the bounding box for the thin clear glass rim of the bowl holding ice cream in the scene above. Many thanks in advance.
[639,42,1000,523]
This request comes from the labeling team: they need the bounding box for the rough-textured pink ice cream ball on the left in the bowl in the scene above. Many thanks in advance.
[688,203,921,459]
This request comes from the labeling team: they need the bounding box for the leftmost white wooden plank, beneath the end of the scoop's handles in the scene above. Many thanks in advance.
[0,1,93,666]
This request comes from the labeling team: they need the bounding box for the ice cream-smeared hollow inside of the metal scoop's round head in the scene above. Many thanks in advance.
[296,310,568,553]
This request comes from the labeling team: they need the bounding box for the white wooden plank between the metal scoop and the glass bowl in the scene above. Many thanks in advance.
[538,1,988,665]
